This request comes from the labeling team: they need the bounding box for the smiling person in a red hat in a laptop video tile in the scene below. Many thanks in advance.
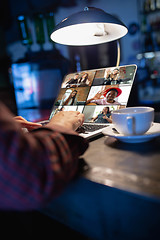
[86,88,122,105]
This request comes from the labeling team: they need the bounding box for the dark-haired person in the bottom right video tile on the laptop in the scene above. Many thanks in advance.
[92,107,112,123]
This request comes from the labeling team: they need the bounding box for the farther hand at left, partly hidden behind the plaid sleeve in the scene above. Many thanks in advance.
[14,116,42,131]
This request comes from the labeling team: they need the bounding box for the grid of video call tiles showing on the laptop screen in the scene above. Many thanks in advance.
[50,64,137,122]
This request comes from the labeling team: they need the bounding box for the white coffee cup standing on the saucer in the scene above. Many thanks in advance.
[112,106,154,135]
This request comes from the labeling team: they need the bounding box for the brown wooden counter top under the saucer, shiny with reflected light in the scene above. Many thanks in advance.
[83,137,160,199]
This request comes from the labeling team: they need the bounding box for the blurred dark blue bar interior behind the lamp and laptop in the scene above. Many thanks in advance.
[0,0,160,121]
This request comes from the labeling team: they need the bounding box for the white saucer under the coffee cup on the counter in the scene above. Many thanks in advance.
[102,123,160,143]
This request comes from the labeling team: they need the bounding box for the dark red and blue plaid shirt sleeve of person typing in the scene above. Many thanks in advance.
[0,104,88,210]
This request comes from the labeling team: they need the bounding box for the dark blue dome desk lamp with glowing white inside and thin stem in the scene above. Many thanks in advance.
[51,7,128,66]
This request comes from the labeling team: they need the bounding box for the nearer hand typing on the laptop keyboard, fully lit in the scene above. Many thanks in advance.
[46,111,84,130]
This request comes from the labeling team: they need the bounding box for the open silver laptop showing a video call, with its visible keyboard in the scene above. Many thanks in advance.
[41,64,137,140]
